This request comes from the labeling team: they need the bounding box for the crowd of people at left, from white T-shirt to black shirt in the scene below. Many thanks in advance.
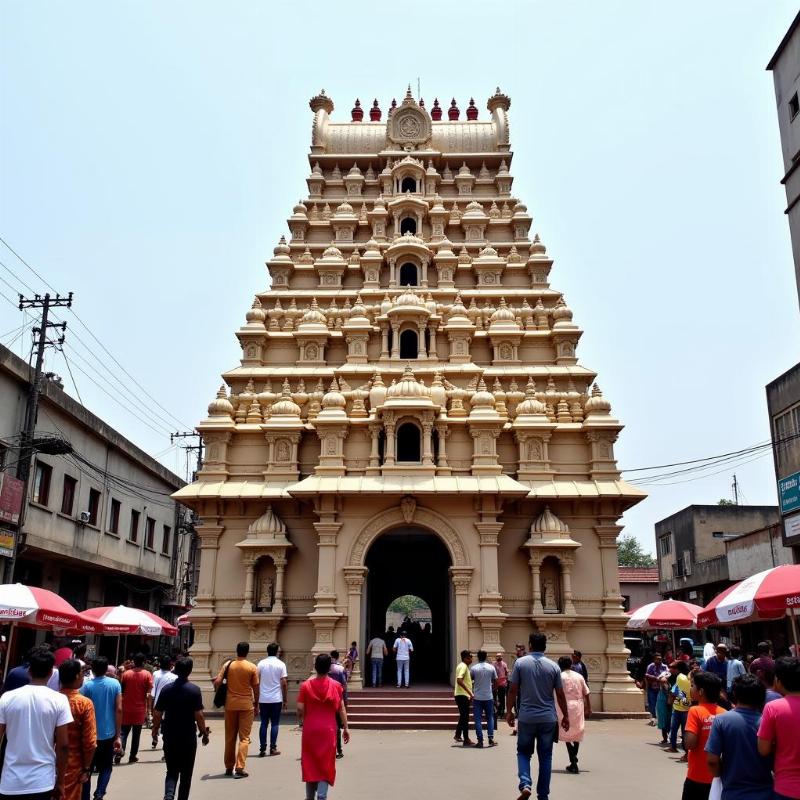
[0,643,209,800]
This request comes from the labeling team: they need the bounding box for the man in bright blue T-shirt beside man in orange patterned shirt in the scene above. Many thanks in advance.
[81,656,122,800]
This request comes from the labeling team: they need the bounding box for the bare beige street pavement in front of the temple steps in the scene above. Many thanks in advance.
[108,719,686,800]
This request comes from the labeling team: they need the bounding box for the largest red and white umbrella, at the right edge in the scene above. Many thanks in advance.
[697,564,800,627]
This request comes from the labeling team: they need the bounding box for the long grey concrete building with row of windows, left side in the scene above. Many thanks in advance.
[0,346,189,656]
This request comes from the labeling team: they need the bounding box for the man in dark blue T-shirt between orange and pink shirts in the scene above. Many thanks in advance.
[706,675,773,800]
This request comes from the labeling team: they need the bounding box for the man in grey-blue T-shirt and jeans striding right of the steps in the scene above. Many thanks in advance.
[506,633,569,800]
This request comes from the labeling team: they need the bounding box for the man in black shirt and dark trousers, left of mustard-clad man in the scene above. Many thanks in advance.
[153,658,208,800]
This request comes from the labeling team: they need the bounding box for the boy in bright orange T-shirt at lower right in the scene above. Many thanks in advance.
[682,671,725,800]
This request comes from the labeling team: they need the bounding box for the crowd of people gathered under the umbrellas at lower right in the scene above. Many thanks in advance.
[636,641,800,800]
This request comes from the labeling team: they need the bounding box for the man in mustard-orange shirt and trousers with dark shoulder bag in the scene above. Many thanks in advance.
[214,642,258,778]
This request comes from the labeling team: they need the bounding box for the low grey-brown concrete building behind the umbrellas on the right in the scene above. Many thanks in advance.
[655,505,779,606]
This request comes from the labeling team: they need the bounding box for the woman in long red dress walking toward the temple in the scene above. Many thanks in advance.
[297,653,350,800]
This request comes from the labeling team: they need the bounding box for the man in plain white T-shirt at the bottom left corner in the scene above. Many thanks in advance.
[0,647,72,800]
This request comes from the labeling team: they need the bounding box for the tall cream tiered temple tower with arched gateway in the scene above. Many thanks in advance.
[177,89,644,710]
